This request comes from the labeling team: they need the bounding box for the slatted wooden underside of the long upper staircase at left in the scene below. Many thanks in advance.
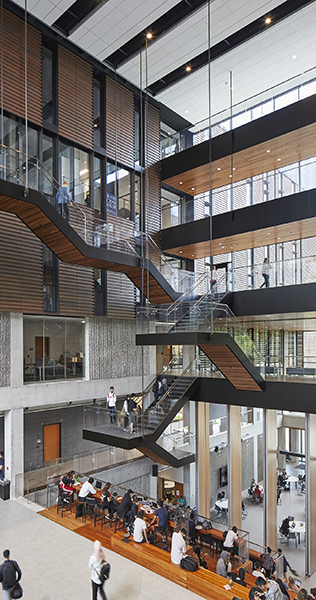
[0,194,172,304]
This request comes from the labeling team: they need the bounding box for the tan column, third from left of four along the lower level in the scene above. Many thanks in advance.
[263,409,277,548]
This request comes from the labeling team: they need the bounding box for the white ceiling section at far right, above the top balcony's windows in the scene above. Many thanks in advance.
[157,3,316,123]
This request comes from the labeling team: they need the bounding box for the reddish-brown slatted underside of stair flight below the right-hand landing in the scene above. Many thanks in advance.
[199,344,262,392]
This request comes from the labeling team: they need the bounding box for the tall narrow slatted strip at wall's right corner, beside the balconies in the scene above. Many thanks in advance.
[145,105,161,252]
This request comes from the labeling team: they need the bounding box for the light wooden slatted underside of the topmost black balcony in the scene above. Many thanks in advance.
[164,123,316,196]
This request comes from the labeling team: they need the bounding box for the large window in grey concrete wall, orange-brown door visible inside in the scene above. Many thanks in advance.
[23,316,84,383]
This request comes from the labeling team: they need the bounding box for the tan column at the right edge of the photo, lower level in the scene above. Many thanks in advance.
[305,414,316,576]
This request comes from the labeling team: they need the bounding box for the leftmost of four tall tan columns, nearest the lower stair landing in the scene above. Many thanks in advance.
[196,402,211,517]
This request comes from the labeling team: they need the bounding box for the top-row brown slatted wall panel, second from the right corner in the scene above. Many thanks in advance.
[106,77,135,168]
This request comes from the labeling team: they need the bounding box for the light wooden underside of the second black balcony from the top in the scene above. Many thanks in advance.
[165,217,316,259]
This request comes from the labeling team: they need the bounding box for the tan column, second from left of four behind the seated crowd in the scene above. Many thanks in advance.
[227,405,242,529]
